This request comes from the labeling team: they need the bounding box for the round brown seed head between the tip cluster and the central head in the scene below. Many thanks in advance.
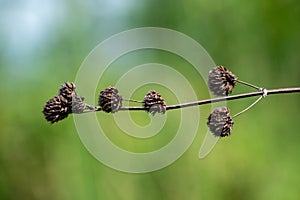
[98,86,122,113]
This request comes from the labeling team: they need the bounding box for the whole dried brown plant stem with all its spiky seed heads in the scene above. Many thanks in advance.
[43,66,300,137]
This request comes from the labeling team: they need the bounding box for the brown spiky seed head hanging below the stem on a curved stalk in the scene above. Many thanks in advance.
[207,107,233,137]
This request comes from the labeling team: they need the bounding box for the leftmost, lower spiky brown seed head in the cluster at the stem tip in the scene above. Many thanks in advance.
[43,95,72,124]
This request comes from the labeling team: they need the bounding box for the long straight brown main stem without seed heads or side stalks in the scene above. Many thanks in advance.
[110,87,300,111]
